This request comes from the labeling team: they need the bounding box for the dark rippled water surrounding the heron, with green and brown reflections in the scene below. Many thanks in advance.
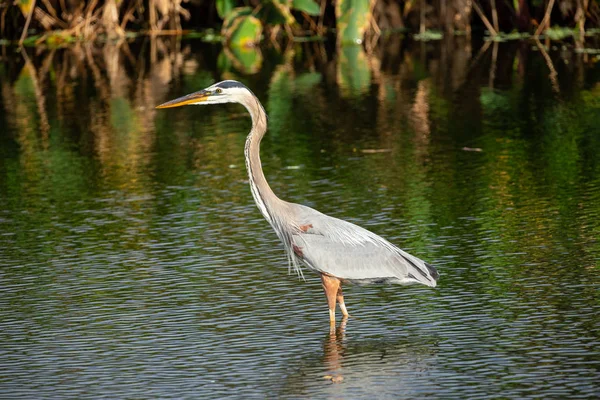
[0,37,600,399]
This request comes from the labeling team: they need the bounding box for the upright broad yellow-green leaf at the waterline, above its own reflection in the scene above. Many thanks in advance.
[335,0,371,44]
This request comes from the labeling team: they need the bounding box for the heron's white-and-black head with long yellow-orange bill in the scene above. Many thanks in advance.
[156,81,252,108]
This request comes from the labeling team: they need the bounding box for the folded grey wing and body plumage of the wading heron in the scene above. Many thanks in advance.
[292,206,439,287]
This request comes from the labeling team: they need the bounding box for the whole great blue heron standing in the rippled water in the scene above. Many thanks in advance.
[156,80,439,323]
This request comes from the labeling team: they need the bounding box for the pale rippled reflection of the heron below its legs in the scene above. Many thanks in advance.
[273,318,439,399]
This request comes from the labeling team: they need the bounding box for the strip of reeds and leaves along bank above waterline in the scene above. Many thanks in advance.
[0,0,600,51]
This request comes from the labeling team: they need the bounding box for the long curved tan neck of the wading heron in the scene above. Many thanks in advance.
[243,96,282,223]
